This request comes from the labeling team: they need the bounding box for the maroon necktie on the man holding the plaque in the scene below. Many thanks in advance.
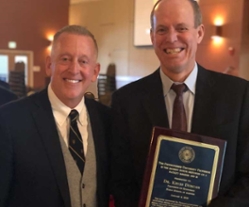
[171,84,188,131]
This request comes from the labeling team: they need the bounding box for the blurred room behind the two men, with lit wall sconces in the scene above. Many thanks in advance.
[0,0,249,105]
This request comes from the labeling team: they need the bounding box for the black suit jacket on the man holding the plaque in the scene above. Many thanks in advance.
[112,66,249,207]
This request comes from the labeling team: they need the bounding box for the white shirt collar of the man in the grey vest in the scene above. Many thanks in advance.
[48,84,86,126]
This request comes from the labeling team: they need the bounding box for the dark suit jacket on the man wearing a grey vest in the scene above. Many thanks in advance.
[0,90,110,207]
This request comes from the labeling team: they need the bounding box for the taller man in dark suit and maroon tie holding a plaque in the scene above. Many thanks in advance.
[112,0,249,207]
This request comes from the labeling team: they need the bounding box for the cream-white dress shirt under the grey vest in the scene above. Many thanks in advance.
[48,84,88,156]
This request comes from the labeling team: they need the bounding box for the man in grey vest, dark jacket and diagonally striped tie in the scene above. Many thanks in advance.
[0,25,110,207]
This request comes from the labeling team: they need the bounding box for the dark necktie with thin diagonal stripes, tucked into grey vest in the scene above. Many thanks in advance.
[68,109,85,174]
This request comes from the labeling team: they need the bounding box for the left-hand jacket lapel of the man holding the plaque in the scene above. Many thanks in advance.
[142,69,169,128]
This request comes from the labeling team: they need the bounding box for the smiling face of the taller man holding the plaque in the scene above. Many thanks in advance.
[151,0,204,82]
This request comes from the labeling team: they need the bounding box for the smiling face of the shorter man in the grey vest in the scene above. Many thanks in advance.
[46,33,100,108]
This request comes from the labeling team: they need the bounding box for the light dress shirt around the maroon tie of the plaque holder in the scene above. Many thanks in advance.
[160,63,198,132]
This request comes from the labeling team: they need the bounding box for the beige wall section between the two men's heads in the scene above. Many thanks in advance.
[69,0,159,79]
